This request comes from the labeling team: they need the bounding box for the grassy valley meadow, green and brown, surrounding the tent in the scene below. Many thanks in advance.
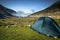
[0,17,60,40]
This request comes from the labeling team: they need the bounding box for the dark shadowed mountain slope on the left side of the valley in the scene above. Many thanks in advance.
[0,4,16,19]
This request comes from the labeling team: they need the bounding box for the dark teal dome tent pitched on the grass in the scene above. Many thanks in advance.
[31,17,60,37]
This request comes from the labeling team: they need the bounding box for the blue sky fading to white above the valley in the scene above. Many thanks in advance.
[0,0,56,13]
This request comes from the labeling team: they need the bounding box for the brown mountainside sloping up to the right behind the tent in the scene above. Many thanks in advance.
[29,1,60,18]
